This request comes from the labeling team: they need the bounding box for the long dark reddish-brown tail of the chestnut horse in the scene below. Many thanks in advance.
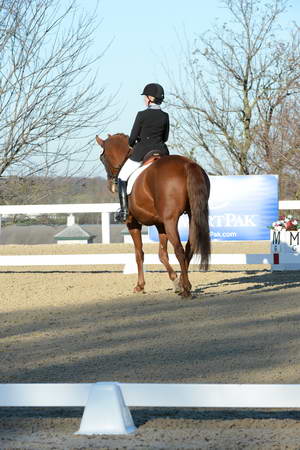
[187,162,211,270]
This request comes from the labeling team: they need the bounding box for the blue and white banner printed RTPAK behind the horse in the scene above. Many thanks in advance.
[149,175,278,241]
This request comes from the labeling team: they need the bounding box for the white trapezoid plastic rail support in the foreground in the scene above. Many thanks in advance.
[76,382,136,435]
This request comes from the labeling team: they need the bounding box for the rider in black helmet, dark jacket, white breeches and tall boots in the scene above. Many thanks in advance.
[115,83,169,223]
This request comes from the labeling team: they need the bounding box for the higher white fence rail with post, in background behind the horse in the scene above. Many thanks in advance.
[0,200,300,244]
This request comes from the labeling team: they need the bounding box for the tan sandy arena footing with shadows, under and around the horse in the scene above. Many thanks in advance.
[0,243,300,450]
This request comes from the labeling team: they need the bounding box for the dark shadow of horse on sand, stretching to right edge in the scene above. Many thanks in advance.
[193,270,300,296]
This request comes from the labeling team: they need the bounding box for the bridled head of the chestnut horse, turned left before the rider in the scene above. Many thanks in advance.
[96,133,131,193]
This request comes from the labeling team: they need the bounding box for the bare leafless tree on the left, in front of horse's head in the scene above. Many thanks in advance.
[0,0,113,177]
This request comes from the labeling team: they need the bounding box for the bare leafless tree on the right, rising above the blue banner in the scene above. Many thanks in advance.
[167,0,300,182]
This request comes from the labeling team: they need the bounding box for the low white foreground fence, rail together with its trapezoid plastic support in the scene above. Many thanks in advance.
[0,382,300,435]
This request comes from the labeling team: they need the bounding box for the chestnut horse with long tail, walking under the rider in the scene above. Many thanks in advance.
[96,133,210,297]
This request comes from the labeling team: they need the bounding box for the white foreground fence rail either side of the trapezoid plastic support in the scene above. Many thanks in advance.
[0,383,300,408]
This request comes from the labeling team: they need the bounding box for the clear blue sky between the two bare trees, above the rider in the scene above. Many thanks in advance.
[84,0,300,134]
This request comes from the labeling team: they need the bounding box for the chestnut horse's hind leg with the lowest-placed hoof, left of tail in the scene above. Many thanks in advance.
[165,220,192,297]
